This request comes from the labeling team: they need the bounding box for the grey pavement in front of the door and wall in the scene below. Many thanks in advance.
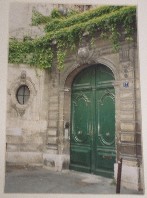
[5,167,142,194]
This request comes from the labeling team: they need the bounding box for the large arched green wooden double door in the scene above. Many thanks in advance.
[70,64,116,177]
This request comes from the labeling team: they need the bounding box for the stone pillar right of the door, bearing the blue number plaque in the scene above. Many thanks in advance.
[115,45,139,189]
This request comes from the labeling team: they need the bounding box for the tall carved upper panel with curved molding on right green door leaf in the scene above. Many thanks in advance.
[96,88,115,147]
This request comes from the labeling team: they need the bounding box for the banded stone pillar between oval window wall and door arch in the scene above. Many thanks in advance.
[43,68,59,169]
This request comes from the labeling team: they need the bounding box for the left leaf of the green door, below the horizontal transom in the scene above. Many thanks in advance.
[70,91,92,172]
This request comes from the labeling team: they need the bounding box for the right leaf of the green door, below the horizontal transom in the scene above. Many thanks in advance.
[96,87,115,176]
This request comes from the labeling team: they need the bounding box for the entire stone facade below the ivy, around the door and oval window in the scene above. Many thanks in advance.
[6,1,143,190]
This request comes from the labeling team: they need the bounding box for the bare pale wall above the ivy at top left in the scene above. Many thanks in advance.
[9,2,54,39]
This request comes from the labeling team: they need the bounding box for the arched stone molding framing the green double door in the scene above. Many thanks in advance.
[59,57,119,158]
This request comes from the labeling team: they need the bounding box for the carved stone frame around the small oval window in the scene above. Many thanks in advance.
[8,71,37,116]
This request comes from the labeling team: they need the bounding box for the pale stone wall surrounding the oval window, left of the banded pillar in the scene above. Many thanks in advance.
[6,65,49,164]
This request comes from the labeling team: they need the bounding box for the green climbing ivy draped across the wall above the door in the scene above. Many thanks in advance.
[9,6,136,69]
